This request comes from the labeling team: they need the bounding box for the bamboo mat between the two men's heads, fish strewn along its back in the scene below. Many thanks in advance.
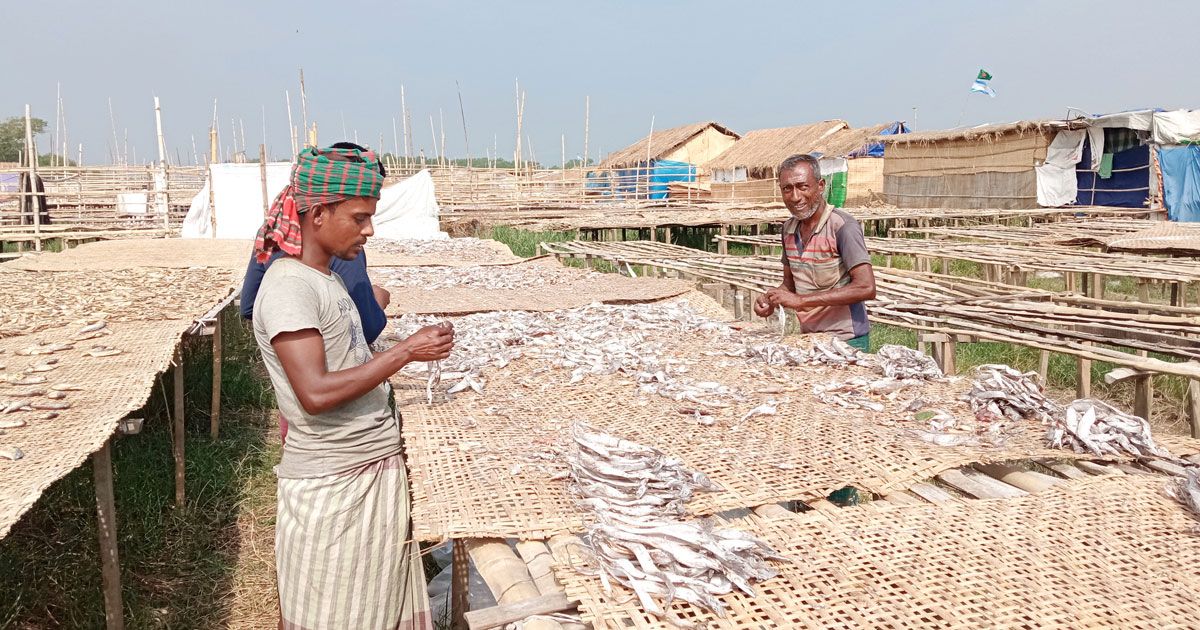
[379,258,692,317]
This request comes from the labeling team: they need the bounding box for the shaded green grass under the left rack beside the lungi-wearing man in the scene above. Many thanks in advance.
[0,313,277,629]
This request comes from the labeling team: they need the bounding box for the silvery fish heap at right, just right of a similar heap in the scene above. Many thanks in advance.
[1046,398,1171,457]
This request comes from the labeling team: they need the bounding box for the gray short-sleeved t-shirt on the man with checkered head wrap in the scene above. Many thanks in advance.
[254,258,400,479]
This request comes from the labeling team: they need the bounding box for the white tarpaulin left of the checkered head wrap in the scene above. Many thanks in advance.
[182,162,292,239]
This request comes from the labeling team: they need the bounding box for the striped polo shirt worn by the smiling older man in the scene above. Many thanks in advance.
[782,205,871,340]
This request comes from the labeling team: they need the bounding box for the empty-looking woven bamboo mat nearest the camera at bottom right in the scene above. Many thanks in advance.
[554,476,1200,630]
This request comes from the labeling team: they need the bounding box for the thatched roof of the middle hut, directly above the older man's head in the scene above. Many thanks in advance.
[704,120,854,169]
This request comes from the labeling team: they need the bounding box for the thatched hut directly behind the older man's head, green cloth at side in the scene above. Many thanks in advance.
[704,120,907,206]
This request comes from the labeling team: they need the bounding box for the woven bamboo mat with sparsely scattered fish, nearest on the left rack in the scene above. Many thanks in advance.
[0,319,191,538]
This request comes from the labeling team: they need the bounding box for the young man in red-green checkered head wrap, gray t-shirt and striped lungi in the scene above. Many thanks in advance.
[253,145,454,630]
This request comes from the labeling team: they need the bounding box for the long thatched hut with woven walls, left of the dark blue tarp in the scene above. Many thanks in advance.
[877,120,1064,209]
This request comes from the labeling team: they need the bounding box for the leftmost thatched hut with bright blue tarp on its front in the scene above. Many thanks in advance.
[587,122,740,199]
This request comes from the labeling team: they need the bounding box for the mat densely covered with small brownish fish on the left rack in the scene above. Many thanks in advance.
[0,264,242,338]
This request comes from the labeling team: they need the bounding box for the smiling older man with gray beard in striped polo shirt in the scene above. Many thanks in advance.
[754,155,875,352]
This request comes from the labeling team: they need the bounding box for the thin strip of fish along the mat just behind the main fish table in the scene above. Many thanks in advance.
[372,265,600,290]
